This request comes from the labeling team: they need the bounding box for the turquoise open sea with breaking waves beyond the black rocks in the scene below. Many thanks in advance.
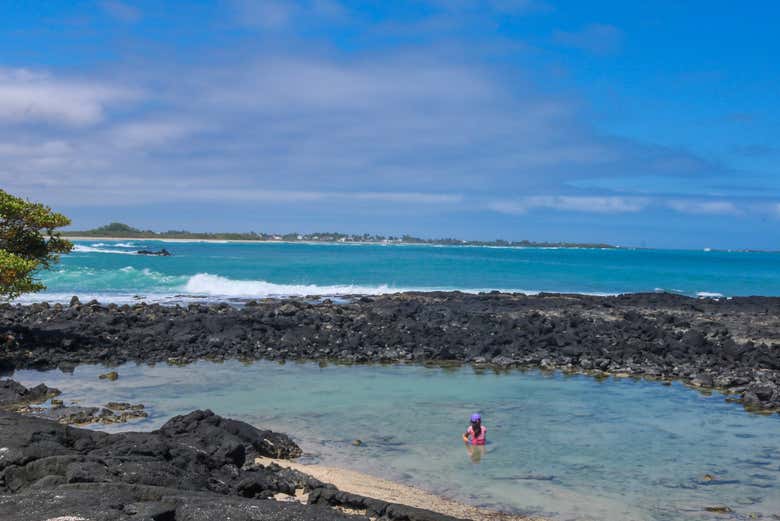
[19,241,780,302]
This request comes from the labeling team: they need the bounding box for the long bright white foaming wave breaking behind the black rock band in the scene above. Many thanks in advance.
[184,273,408,297]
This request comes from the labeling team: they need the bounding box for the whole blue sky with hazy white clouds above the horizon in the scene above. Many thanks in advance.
[0,0,780,249]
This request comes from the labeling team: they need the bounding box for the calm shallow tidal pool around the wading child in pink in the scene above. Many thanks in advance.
[14,362,780,521]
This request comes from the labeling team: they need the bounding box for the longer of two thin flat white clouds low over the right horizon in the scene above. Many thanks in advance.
[488,195,649,214]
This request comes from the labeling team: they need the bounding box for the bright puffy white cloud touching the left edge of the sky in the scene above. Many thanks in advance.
[0,68,137,126]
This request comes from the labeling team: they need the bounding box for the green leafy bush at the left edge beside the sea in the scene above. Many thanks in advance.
[0,190,73,299]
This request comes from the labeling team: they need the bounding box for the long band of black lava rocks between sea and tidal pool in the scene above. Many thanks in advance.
[0,292,780,412]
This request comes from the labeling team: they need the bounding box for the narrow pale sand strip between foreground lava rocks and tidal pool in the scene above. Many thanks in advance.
[255,458,544,521]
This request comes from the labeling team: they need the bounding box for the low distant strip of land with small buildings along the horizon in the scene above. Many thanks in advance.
[62,222,617,248]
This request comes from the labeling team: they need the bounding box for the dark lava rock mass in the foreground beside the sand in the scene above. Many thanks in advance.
[0,402,470,521]
